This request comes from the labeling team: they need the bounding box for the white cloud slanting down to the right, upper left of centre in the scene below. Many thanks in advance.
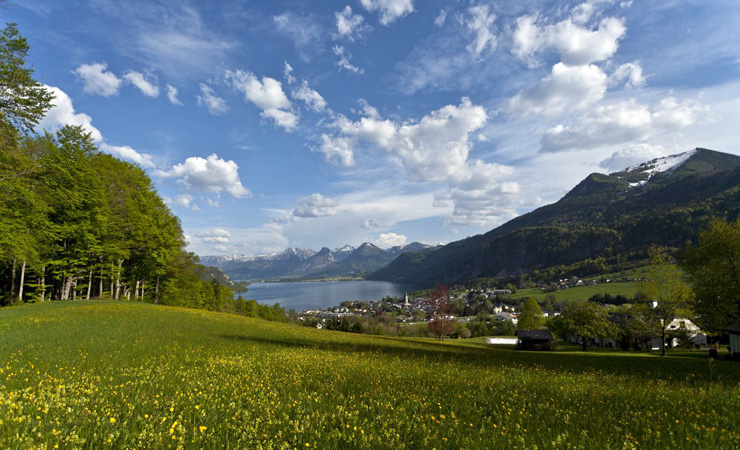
[226,70,298,131]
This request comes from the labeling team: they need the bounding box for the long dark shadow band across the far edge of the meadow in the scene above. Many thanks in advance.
[218,333,740,386]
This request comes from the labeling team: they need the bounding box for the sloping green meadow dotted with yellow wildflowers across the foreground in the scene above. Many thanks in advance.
[0,302,740,449]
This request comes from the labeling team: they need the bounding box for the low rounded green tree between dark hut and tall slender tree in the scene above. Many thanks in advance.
[550,301,617,351]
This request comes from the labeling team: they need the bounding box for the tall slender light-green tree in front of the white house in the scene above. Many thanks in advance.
[635,247,692,356]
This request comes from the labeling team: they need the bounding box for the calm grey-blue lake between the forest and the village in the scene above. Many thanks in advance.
[241,281,419,312]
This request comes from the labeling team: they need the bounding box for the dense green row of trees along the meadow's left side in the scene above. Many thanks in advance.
[0,24,286,320]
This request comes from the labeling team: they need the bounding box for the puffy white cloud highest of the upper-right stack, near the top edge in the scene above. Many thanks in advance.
[512,15,627,66]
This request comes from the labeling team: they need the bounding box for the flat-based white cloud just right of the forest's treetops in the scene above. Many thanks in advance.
[155,153,251,198]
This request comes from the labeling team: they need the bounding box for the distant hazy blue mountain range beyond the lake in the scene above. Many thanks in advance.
[201,242,432,280]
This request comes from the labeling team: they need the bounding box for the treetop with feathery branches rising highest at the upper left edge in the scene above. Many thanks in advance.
[0,23,54,132]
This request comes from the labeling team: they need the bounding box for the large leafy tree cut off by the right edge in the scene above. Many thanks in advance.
[680,218,740,331]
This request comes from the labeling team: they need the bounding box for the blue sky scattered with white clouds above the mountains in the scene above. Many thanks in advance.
[10,0,740,256]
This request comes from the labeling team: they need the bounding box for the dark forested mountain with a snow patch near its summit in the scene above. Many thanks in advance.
[368,148,740,285]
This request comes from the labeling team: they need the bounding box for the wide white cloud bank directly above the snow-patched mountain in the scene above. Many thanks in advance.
[542,96,708,152]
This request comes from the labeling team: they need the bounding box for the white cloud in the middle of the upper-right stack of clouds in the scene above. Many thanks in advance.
[508,62,607,116]
